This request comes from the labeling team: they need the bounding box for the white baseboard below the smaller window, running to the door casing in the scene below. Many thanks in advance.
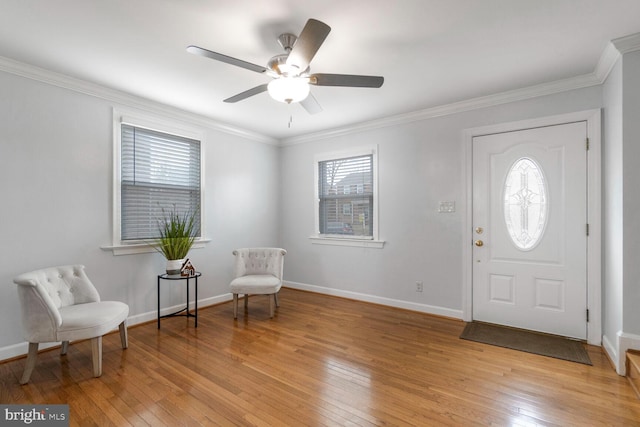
[283,282,462,319]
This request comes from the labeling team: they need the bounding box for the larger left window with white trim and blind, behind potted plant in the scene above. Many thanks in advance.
[110,113,203,254]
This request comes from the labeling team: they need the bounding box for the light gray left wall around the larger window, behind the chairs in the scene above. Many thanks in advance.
[0,72,280,359]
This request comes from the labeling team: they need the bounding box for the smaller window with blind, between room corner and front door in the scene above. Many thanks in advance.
[312,149,382,247]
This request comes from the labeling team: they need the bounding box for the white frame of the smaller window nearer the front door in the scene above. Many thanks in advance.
[309,145,385,249]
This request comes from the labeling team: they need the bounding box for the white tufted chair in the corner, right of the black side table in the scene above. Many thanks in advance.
[229,248,287,319]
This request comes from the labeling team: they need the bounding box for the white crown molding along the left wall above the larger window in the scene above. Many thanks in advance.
[0,56,279,145]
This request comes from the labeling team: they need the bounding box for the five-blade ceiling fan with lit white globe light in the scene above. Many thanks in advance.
[187,19,384,114]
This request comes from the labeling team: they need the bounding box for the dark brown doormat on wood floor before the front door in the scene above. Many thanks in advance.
[460,322,592,365]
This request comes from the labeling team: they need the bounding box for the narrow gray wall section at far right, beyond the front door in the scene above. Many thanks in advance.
[603,51,640,375]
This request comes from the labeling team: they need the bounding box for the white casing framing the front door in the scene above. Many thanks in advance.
[462,109,602,346]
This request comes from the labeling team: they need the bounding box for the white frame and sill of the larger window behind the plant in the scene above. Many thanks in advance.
[107,108,210,255]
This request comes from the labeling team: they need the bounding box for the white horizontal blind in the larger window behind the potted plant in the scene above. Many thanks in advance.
[120,124,201,241]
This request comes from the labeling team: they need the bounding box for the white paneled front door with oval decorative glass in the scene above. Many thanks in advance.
[472,122,587,339]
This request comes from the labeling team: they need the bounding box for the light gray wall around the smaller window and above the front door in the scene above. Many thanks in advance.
[281,86,602,317]
